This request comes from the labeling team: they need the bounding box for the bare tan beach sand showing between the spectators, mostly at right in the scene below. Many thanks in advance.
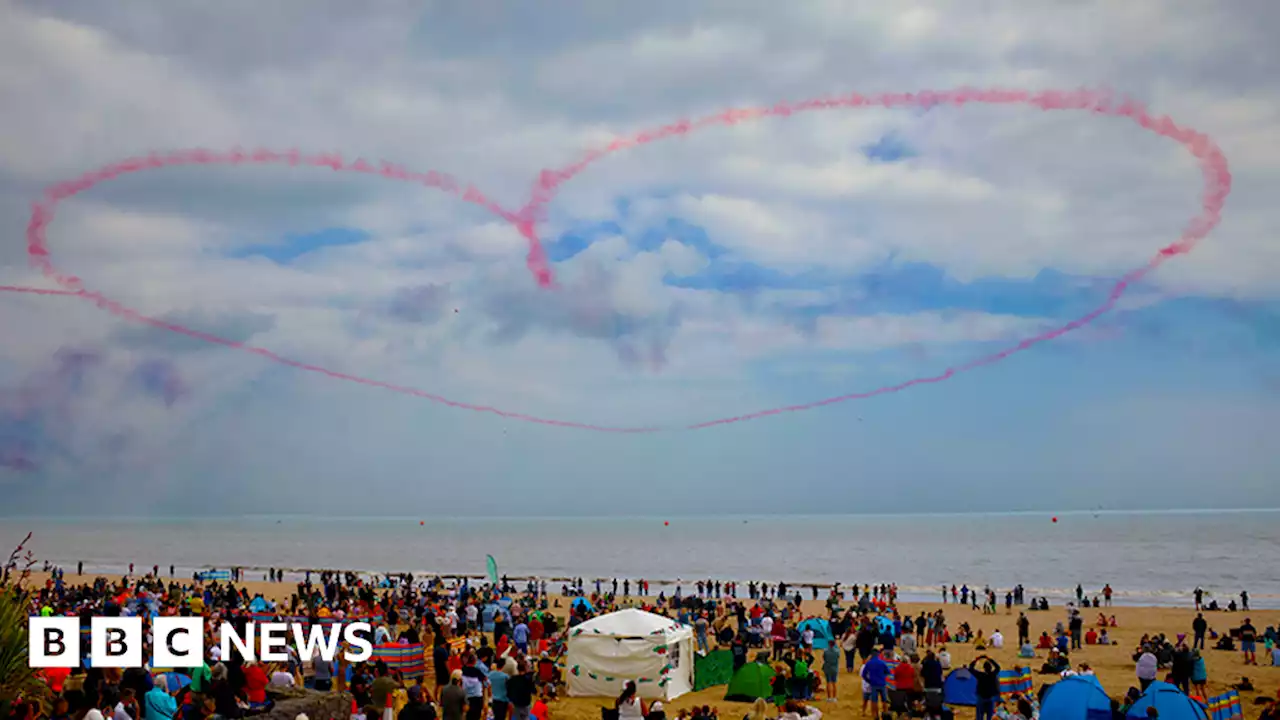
[17,573,1280,720]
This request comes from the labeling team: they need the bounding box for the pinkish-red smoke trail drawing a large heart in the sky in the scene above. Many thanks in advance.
[0,88,1231,433]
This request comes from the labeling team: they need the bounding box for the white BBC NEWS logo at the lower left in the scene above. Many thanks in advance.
[27,618,374,667]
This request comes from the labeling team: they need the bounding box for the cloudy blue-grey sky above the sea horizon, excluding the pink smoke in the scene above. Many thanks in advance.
[0,0,1280,516]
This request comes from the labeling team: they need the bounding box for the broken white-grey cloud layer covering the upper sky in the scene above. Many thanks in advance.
[0,0,1280,497]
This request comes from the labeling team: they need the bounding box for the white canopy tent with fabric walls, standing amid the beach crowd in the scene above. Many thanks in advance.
[564,609,694,700]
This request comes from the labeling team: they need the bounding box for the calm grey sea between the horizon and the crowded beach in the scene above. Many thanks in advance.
[0,510,1280,609]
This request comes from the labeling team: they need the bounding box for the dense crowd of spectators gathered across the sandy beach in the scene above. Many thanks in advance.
[12,568,1280,720]
